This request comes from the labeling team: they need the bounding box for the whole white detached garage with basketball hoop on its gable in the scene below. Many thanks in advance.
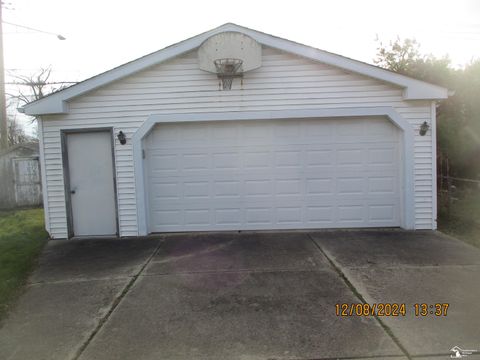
[19,23,448,238]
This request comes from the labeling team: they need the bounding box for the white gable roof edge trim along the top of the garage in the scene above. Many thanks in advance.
[19,23,448,115]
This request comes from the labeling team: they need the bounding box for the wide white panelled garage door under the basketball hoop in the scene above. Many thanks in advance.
[144,118,401,232]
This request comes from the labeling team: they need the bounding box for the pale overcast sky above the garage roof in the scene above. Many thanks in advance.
[3,0,480,134]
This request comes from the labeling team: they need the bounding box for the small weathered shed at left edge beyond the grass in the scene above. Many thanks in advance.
[0,142,42,210]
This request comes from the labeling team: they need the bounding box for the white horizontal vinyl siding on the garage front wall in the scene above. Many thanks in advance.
[42,47,435,238]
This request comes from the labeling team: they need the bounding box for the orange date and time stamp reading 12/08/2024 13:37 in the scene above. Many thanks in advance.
[335,303,450,317]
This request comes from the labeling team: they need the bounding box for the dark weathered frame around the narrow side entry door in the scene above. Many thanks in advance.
[60,127,120,239]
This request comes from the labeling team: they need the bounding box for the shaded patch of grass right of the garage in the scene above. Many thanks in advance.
[438,190,480,248]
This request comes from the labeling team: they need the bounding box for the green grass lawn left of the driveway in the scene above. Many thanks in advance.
[0,209,47,320]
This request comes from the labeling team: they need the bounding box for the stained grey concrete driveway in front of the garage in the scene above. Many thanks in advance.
[0,230,480,360]
